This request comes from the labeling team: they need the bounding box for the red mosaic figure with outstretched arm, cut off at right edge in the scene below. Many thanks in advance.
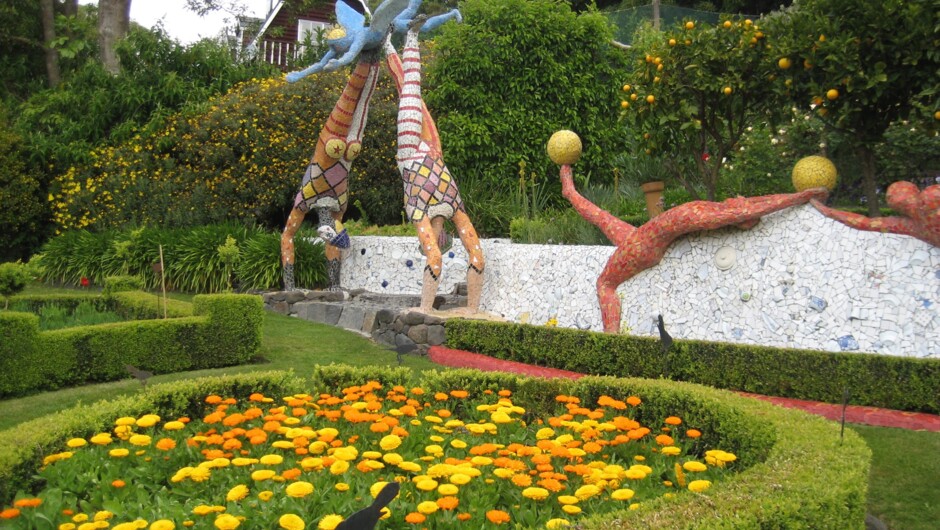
[810,181,940,247]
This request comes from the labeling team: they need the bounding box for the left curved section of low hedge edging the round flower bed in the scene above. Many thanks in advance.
[0,372,303,505]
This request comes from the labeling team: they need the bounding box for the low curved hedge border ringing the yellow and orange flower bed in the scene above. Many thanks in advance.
[0,365,871,530]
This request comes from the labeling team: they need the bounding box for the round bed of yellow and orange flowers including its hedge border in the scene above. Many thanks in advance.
[0,367,869,530]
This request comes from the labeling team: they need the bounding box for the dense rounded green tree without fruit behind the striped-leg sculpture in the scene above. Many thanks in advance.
[424,0,625,193]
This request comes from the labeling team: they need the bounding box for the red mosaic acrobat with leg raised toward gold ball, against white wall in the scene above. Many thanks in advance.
[553,131,829,333]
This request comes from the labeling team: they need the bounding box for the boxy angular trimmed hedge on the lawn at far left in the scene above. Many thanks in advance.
[0,292,263,397]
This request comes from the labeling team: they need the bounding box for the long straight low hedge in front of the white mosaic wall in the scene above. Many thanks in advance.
[446,320,940,414]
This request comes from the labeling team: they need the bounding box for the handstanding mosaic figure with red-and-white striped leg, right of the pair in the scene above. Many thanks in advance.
[385,9,484,313]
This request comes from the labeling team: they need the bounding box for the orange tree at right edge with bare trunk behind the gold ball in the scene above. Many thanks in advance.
[767,0,940,215]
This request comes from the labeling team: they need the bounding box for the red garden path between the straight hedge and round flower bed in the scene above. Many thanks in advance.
[428,346,940,432]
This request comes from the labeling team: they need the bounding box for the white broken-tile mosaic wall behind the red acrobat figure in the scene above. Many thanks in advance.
[341,205,940,358]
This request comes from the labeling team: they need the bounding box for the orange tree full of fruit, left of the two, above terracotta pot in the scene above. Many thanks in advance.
[620,19,781,200]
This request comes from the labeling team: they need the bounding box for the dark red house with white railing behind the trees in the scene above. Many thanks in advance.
[237,0,336,70]
